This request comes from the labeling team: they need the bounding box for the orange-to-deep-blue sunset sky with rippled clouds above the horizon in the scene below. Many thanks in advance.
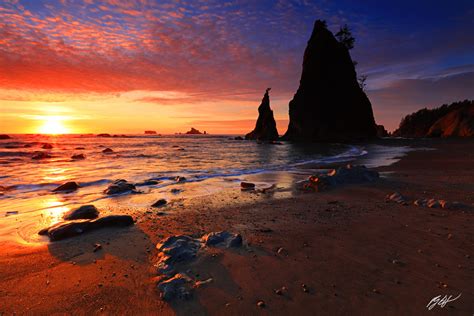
[0,0,474,134]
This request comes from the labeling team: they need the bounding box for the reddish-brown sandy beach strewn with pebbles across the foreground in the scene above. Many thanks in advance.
[0,141,474,315]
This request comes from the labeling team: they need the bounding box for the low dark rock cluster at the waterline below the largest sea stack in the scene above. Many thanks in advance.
[303,164,379,192]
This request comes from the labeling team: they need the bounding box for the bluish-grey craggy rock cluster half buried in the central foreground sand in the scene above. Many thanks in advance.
[155,231,243,301]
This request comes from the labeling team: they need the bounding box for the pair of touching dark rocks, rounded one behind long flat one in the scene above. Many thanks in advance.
[38,205,134,241]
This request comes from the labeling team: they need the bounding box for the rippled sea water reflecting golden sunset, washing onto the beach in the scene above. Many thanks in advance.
[0,135,408,241]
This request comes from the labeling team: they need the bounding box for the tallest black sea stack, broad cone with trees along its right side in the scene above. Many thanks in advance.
[284,20,377,142]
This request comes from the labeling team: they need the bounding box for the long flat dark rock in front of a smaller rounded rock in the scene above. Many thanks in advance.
[38,215,133,241]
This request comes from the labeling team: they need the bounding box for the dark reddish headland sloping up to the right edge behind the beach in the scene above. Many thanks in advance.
[393,100,474,137]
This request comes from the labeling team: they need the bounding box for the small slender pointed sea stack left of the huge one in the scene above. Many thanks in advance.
[245,88,278,140]
